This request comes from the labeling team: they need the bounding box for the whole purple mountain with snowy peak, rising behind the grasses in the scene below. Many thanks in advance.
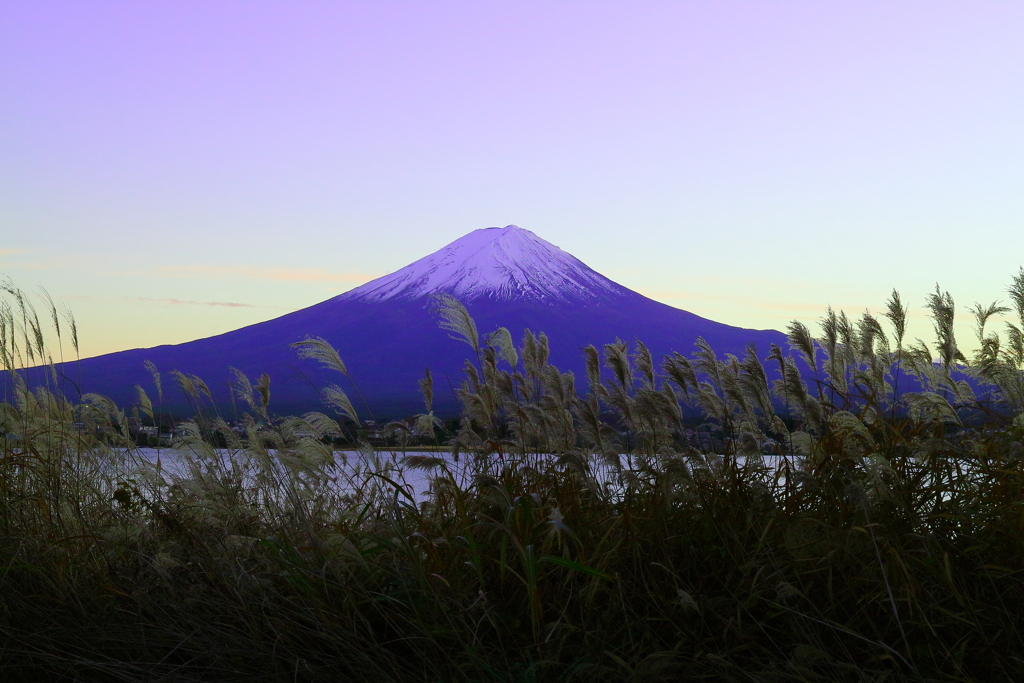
[16,225,785,417]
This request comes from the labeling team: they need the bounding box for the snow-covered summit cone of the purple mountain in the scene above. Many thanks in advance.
[338,225,629,303]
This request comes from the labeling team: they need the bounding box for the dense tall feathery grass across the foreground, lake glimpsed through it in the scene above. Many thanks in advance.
[0,270,1024,682]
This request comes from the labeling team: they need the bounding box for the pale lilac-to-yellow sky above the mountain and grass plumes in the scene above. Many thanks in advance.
[0,0,1024,362]
